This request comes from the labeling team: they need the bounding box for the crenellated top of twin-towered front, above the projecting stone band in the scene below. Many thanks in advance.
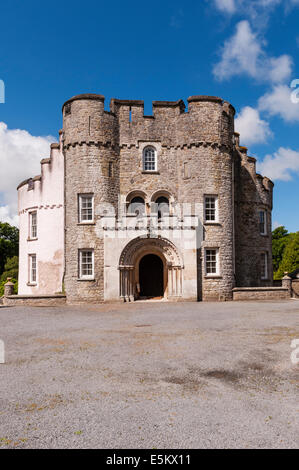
[63,94,235,147]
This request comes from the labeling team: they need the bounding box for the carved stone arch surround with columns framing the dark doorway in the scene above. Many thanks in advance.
[119,237,184,302]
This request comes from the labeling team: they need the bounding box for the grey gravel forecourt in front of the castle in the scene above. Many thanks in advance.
[0,300,299,449]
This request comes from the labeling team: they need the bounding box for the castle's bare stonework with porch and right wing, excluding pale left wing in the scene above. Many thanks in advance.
[16,94,273,302]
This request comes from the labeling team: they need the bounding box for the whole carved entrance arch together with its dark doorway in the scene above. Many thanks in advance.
[119,236,184,301]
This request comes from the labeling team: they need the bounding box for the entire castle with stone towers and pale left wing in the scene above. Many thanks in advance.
[18,94,273,302]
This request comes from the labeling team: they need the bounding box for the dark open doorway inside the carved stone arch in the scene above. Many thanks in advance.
[139,254,164,298]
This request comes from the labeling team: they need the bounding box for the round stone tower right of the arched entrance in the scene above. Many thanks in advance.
[177,96,235,300]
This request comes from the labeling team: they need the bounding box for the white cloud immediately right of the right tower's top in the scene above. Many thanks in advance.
[235,106,272,145]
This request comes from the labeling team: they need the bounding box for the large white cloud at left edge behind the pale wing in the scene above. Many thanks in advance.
[0,122,55,227]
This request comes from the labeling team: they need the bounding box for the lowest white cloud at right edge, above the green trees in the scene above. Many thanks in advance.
[257,147,299,181]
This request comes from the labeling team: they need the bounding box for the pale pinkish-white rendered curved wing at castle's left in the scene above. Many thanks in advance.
[18,138,64,295]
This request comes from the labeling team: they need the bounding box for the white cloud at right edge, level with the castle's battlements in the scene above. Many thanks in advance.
[258,85,299,122]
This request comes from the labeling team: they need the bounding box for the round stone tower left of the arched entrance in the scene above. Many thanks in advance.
[62,94,119,302]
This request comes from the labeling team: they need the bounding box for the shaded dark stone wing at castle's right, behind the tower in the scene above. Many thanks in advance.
[234,138,273,287]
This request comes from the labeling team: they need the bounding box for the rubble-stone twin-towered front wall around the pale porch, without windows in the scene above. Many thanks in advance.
[63,95,240,301]
